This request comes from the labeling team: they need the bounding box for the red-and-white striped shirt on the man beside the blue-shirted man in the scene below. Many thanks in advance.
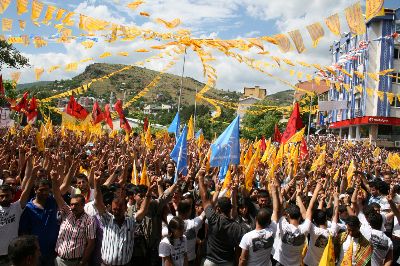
[56,205,96,259]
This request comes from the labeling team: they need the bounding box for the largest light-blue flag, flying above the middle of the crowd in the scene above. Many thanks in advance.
[210,116,240,167]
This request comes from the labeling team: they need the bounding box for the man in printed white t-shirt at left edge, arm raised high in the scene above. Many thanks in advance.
[0,156,35,265]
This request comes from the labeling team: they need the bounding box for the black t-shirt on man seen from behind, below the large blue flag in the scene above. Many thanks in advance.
[205,206,246,264]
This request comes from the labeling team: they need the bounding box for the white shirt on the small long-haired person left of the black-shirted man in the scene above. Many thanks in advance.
[158,236,187,266]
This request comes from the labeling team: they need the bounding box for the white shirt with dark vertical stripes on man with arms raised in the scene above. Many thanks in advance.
[100,212,136,265]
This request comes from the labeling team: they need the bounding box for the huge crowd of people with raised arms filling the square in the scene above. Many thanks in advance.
[0,127,400,266]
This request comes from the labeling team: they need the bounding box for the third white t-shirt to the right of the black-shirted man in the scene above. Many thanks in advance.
[304,223,339,266]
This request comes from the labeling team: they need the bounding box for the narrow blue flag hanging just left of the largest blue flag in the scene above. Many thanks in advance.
[170,125,188,182]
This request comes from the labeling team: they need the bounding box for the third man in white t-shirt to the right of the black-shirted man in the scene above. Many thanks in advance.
[304,193,339,266]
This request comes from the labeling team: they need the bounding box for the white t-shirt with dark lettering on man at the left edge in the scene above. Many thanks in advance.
[0,200,23,256]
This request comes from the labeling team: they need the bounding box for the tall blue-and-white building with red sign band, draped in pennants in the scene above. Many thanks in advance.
[324,9,400,147]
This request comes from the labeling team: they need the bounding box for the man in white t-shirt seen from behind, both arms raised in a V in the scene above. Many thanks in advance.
[274,180,322,265]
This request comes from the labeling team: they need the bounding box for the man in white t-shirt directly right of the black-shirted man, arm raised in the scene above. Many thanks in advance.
[239,180,280,266]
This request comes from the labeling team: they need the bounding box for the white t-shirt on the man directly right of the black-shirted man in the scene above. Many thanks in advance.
[239,221,277,266]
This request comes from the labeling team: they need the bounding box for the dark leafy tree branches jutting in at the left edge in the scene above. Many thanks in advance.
[0,40,29,70]
